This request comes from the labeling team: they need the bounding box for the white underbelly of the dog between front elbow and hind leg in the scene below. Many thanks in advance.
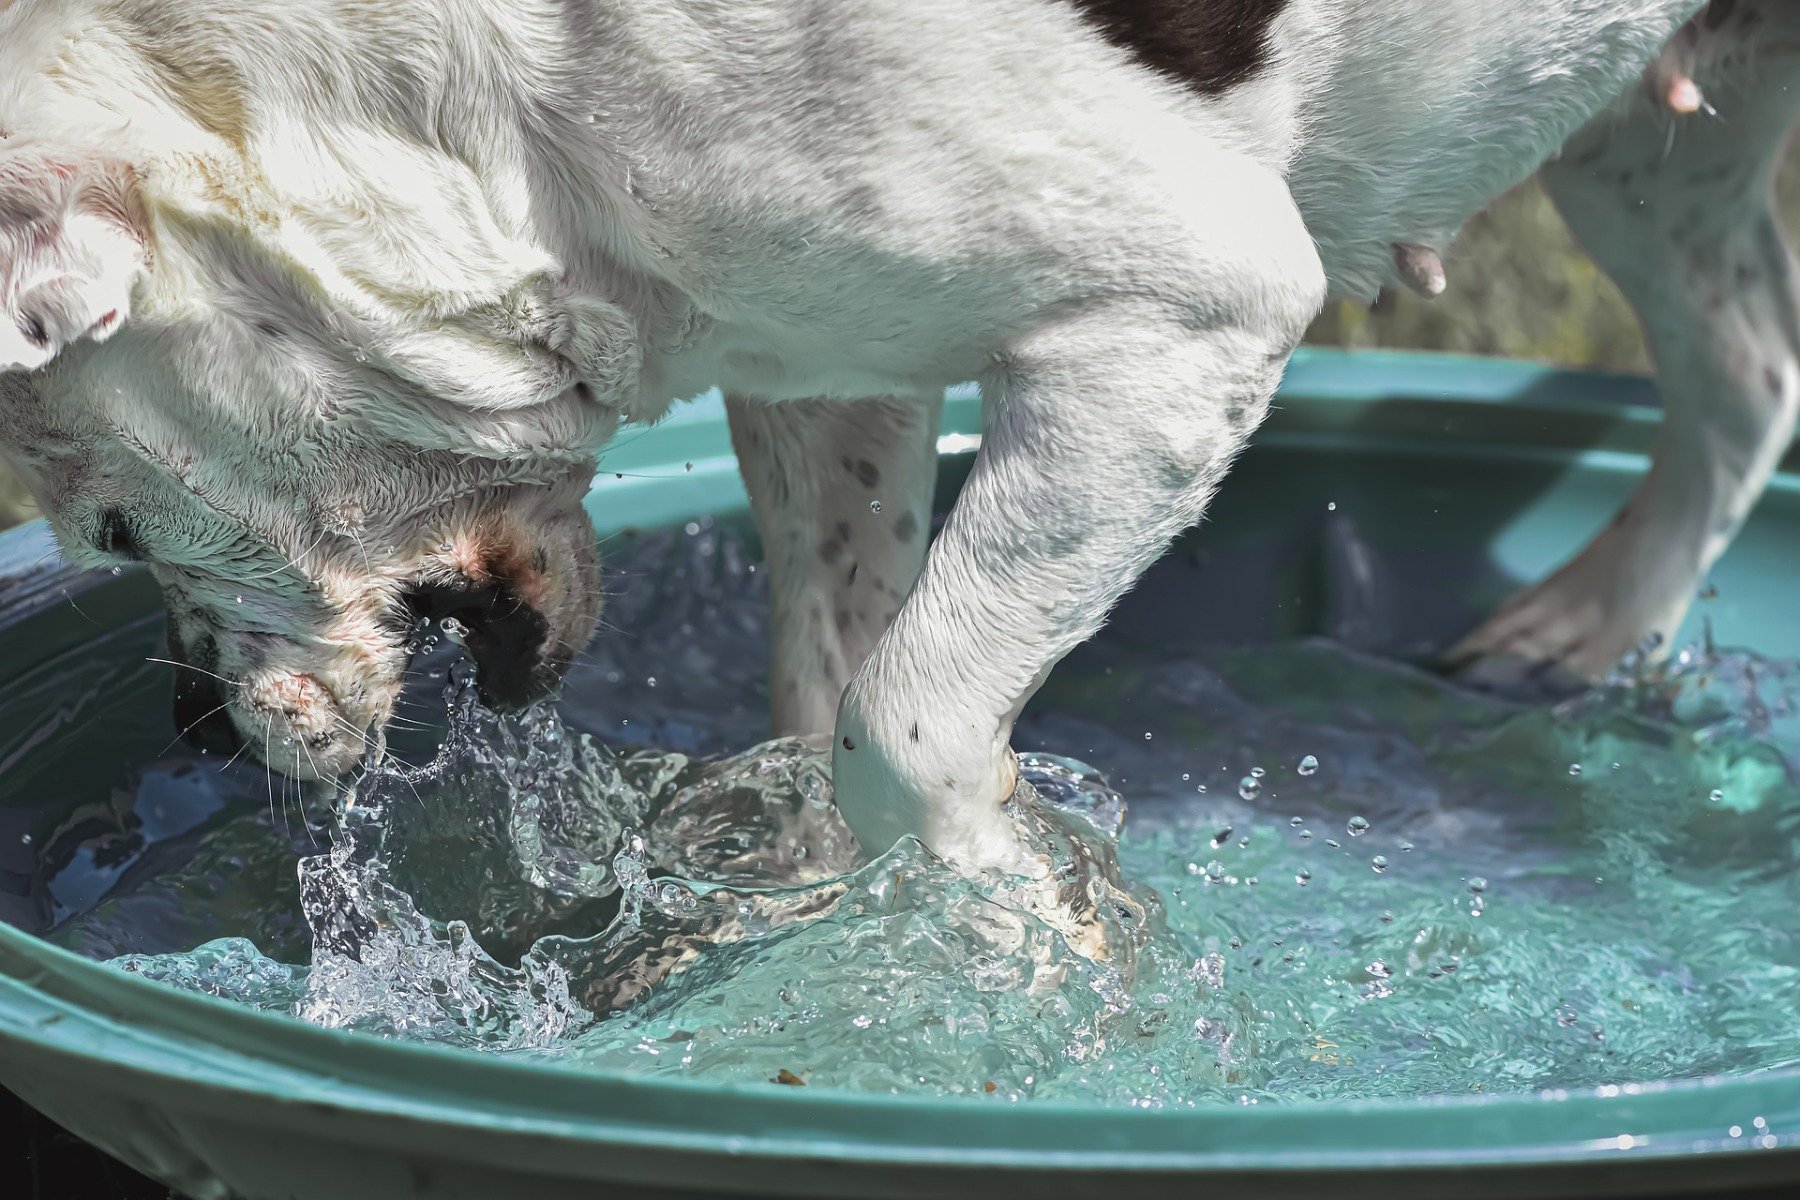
[1274,0,1701,297]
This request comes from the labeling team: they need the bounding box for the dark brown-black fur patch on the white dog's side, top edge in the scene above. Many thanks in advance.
[1069,0,1287,95]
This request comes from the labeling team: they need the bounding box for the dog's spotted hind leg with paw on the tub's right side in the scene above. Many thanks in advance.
[1449,2,1800,691]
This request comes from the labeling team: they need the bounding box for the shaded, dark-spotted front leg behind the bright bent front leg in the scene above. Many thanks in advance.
[725,396,943,736]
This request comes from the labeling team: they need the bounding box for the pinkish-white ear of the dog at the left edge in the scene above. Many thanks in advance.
[0,139,149,371]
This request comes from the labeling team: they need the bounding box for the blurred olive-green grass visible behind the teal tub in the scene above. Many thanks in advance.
[0,150,1800,529]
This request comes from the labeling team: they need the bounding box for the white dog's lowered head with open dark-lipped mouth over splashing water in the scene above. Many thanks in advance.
[0,9,637,777]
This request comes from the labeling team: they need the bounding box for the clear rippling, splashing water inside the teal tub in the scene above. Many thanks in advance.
[31,527,1800,1106]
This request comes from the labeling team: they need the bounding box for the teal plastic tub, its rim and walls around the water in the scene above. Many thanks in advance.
[0,353,1800,1200]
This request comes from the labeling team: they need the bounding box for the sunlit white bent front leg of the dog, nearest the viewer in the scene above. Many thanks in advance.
[833,197,1325,871]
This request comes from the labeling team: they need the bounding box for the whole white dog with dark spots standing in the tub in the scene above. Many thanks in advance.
[0,0,1800,867]
